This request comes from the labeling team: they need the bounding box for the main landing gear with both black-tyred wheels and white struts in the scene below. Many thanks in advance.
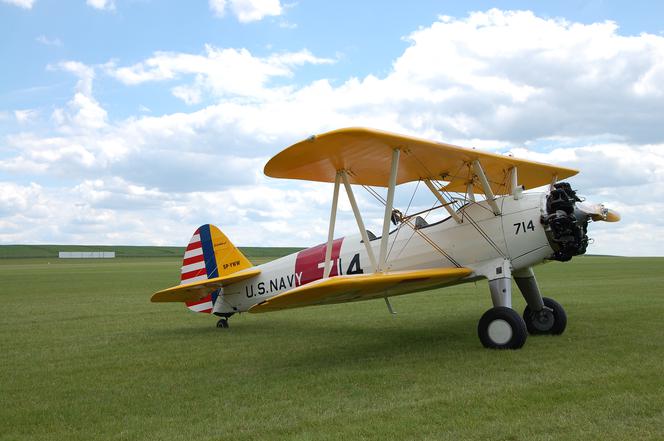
[477,266,567,349]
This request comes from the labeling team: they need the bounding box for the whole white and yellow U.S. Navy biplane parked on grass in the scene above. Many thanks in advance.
[152,128,620,349]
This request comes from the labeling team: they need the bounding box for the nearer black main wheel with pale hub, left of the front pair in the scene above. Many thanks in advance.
[477,306,528,349]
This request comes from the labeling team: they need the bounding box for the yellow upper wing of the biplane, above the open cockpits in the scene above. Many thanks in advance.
[265,128,578,195]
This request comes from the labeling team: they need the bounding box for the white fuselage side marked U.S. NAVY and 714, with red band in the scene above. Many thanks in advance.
[214,193,554,313]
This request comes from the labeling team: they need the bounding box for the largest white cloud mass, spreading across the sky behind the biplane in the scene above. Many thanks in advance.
[0,9,664,254]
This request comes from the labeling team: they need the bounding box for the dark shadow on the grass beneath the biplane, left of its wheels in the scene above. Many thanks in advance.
[148,308,481,368]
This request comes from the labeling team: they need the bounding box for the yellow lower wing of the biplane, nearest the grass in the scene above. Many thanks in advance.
[249,268,472,312]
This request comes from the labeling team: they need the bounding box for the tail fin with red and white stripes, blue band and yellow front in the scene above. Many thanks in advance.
[180,224,253,314]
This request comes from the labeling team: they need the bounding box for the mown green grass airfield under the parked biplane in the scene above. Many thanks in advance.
[0,257,664,441]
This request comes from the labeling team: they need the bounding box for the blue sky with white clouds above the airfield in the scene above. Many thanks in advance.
[0,0,664,256]
